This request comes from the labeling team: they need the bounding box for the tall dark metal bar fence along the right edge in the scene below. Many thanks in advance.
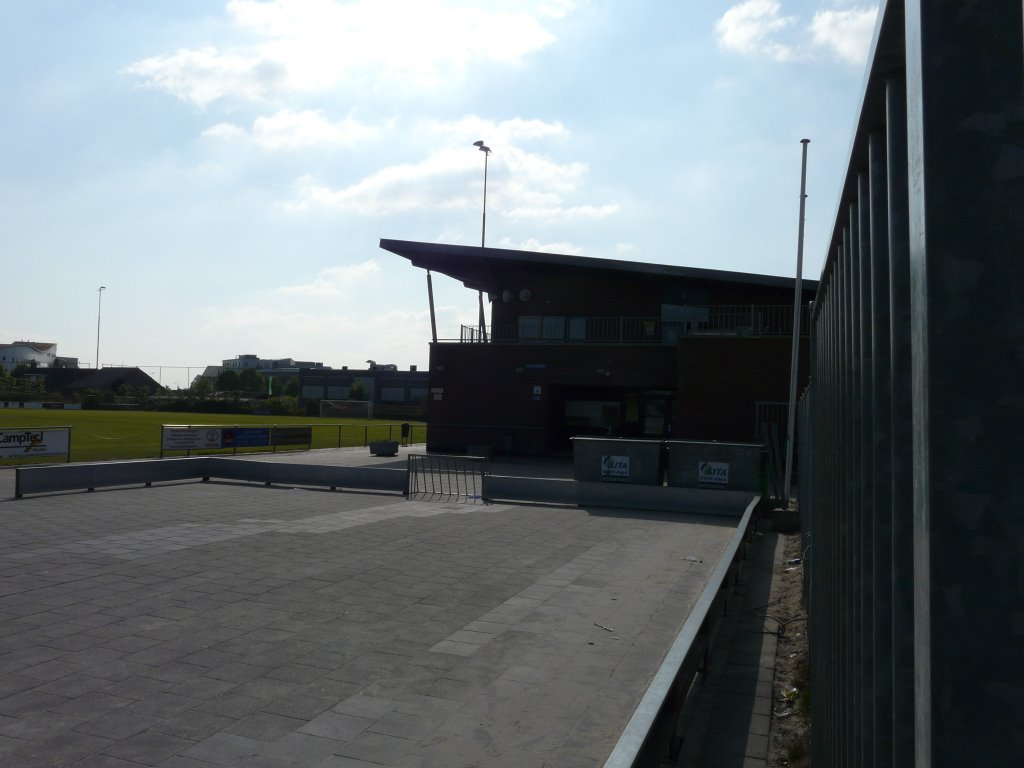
[800,0,1024,768]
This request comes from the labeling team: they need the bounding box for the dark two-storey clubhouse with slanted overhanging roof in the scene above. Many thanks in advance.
[381,240,816,454]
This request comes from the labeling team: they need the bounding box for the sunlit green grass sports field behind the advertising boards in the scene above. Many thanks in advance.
[0,409,426,466]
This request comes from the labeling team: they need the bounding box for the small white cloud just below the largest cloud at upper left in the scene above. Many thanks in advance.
[203,110,380,152]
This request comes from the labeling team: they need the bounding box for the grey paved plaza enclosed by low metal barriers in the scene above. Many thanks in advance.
[0,454,735,768]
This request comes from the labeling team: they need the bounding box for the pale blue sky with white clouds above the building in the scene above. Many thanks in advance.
[0,0,877,387]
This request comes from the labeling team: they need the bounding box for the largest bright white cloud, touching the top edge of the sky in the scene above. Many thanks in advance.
[125,0,573,106]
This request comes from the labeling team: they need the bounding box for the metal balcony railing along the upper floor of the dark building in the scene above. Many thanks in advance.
[459,304,808,344]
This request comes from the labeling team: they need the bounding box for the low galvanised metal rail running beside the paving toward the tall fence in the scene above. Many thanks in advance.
[604,497,761,768]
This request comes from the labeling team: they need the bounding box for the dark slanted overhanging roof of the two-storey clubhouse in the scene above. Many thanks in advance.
[380,238,817,293]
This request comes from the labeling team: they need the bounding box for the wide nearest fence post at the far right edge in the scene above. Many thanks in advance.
[906,0,1024,768]
